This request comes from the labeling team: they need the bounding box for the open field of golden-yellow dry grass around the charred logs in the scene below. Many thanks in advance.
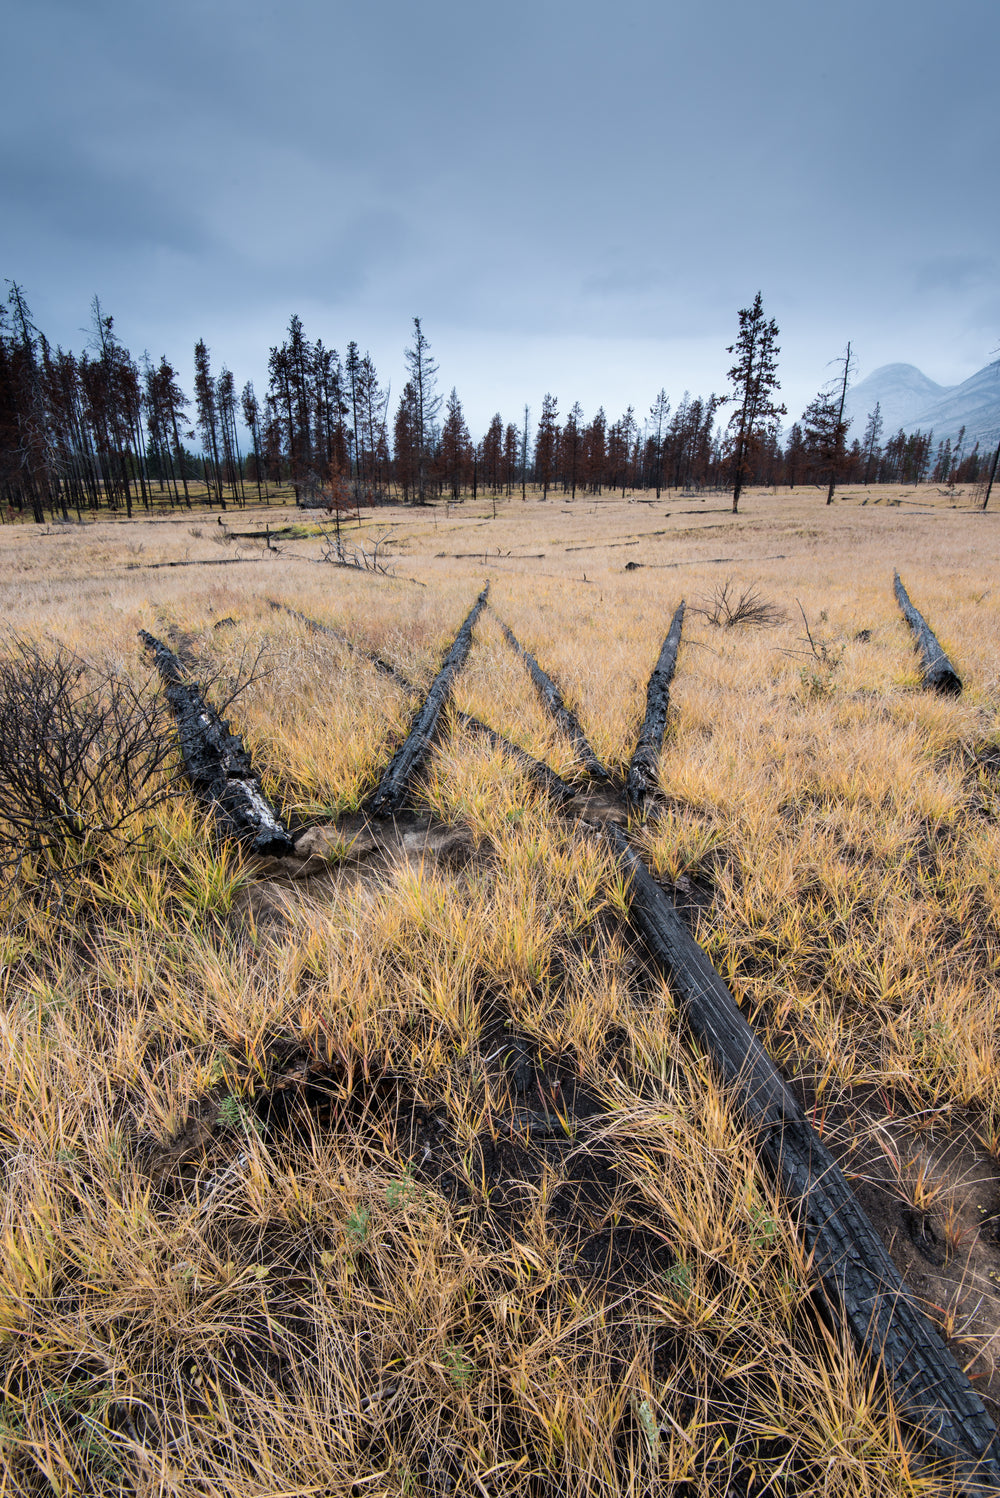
[0,487,1000,1498]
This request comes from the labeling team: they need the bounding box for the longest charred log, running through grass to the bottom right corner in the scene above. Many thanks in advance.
[605,824,1000,1495]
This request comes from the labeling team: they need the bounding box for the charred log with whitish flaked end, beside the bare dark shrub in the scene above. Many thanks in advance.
[139,629,293,858]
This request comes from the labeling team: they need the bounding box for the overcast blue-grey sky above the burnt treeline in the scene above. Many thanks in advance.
[0,0,1000,436]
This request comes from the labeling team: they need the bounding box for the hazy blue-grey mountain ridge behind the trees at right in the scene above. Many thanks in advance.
[844,360,1000,452]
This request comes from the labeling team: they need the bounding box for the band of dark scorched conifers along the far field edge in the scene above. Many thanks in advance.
[0,283,991,523]
